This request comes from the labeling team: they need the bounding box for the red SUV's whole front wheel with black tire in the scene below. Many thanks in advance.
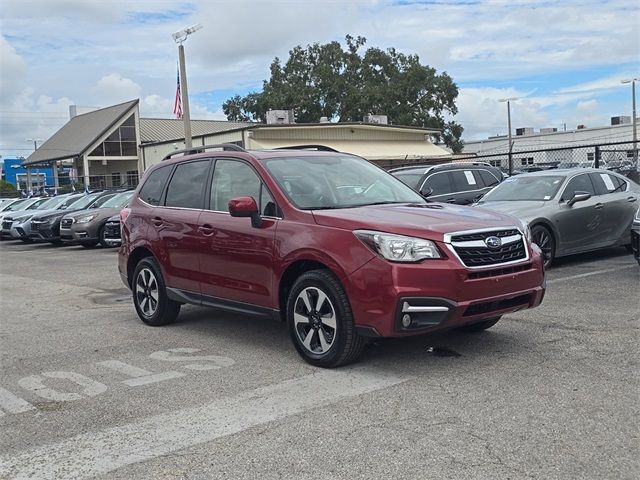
[287,270,367,368]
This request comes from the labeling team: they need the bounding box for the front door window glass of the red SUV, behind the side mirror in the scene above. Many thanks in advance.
[209,160,277,216]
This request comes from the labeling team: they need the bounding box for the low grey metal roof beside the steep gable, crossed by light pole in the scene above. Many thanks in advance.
[140,118,254,144]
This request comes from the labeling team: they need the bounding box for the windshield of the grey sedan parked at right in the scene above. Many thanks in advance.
[478,175,565,203]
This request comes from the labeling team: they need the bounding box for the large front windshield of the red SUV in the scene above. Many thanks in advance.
[265,155,426,210]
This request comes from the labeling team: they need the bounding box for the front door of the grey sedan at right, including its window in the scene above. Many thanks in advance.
[554,173,606,253]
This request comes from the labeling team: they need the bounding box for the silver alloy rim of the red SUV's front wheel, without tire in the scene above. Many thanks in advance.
[293,287,337,355]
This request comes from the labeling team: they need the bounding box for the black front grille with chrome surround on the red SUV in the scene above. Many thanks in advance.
[450,229,528,268]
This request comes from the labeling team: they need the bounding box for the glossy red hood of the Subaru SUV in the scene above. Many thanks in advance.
[313,202,519,240]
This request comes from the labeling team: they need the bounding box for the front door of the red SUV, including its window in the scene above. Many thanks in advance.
[198,158,279,311]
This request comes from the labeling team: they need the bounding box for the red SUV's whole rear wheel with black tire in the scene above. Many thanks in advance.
[131,257,180,327]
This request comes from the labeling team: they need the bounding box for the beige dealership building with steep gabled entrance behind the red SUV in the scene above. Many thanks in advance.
[22,100,450,188]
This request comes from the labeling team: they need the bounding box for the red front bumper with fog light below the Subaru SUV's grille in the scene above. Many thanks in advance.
[345,248,545,337]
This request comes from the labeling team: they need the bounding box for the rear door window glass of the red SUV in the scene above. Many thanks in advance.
[165,160,211,209]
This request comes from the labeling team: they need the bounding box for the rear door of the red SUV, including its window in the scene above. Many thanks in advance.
[154,160,211,293]
